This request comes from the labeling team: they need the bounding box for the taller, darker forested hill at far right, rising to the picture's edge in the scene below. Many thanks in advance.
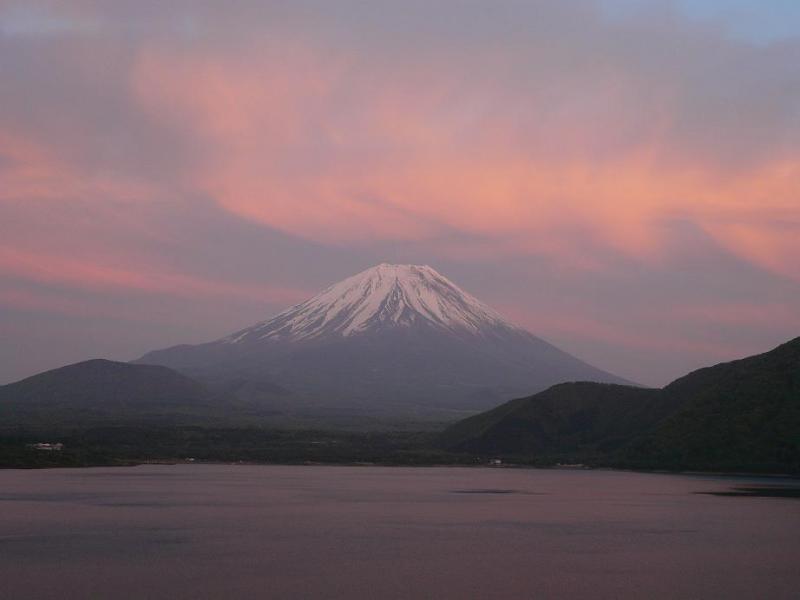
[629,338,800,470]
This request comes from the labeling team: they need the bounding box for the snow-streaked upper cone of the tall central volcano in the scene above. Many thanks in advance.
[222,263,514,344]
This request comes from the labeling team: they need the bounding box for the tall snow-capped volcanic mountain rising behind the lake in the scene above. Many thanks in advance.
[136,263,628,418]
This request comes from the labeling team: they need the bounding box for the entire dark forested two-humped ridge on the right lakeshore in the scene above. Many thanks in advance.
[440,338,800,471]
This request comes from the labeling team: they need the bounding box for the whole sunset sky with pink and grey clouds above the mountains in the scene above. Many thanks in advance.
[0,0,800,385]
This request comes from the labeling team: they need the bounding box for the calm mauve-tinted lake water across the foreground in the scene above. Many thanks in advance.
[0,465,800,600]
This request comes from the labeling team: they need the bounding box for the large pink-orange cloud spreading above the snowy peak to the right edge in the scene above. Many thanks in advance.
[133,41,800,278]
